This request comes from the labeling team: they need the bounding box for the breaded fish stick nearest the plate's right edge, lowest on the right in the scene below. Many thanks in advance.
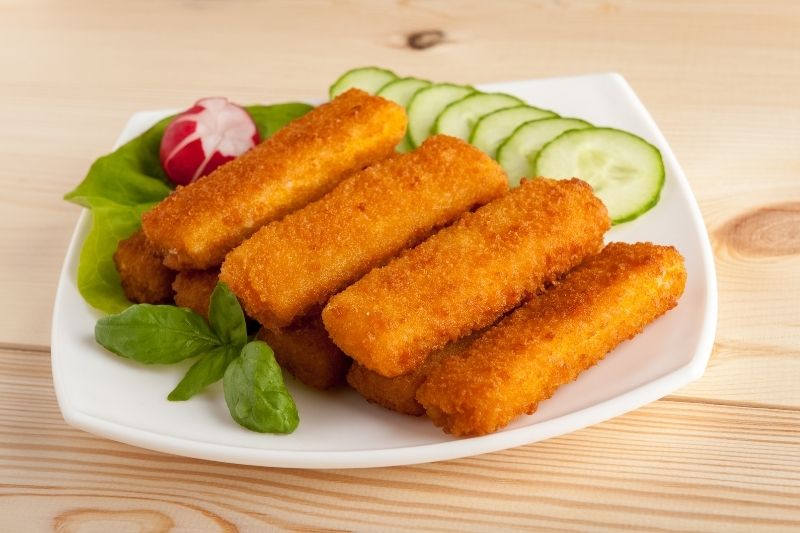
[417,243,686,436]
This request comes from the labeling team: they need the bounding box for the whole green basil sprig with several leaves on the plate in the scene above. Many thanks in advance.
[95,283,299,433]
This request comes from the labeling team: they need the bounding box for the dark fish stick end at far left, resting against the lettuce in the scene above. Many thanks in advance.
[114,230,175,304]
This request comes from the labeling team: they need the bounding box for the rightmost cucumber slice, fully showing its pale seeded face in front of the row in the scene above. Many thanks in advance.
[535,128,664,224]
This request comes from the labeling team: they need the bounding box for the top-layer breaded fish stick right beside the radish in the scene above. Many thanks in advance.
[142,89,407,270]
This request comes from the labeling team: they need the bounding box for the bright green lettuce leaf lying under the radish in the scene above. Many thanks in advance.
[64,103,313,313]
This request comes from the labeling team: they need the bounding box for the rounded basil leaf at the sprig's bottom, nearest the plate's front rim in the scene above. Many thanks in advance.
[222,341,300,433]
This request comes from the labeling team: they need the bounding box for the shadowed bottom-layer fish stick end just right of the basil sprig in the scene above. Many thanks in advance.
[258,315,352,389]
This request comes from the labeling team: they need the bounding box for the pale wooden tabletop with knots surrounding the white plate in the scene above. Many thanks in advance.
[0,0,800,531]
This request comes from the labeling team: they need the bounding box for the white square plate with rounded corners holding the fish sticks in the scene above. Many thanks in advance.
[52,74,717,468]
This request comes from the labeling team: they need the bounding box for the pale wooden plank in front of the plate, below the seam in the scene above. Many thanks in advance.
[0,351,800,531]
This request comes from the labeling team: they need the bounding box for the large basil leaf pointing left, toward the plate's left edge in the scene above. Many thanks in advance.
[94,304,221,364]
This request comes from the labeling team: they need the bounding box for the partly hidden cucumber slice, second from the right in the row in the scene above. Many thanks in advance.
[497,118,592,187]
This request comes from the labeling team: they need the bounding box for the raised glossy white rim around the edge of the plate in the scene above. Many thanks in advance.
[51,72,718,469]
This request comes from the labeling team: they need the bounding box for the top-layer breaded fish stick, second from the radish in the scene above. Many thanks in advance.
[220,135,508,329]
